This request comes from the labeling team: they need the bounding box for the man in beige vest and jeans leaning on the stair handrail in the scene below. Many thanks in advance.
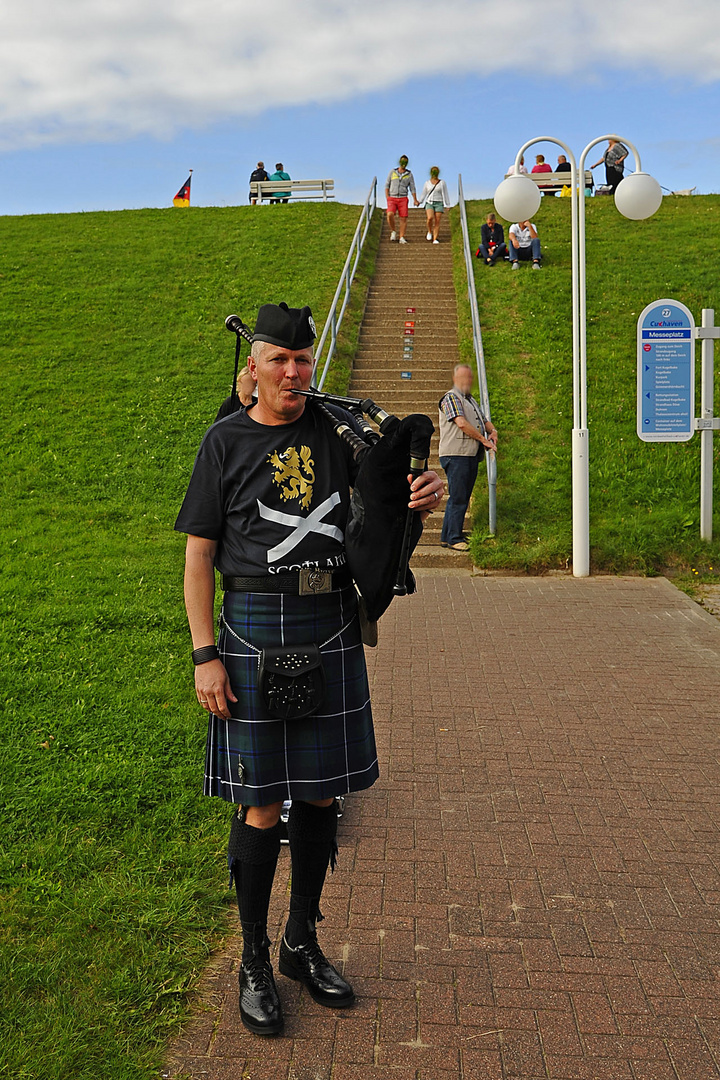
[438,364,498,551]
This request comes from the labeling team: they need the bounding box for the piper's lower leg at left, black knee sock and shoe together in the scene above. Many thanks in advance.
[228,811,283,1035]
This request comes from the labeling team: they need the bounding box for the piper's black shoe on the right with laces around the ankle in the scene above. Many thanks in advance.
[277,893,355,1009]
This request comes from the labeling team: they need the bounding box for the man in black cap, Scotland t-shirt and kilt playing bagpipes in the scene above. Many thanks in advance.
[175,303,443,1035]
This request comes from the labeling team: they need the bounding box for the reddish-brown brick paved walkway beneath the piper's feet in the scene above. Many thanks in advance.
[166,571,720,1080]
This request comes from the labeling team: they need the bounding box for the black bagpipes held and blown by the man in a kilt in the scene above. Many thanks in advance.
[226,315,435,630]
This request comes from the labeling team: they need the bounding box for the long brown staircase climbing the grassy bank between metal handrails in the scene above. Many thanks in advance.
[349,210,472,569]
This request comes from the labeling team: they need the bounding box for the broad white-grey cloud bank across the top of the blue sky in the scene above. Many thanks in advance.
[0,0,720,149]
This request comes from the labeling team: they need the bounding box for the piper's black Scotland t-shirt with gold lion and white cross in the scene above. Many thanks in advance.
[175,406,357,577]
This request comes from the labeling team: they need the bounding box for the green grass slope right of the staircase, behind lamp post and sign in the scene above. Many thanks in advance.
[453,195,720,572]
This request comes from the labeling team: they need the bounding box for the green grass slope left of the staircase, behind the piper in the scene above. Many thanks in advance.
[0,204,379,1080]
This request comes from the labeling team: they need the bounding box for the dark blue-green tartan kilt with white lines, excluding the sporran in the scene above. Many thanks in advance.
[203,585,379,806]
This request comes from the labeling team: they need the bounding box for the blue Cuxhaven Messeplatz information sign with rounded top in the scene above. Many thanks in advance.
[638,300,695,443]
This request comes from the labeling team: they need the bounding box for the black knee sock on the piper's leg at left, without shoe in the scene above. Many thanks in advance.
[228,810,280,960]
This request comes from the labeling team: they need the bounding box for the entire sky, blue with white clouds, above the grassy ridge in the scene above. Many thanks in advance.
[0,0,720,214]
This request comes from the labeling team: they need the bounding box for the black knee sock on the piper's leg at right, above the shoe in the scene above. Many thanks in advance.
[285,800,338,948]
